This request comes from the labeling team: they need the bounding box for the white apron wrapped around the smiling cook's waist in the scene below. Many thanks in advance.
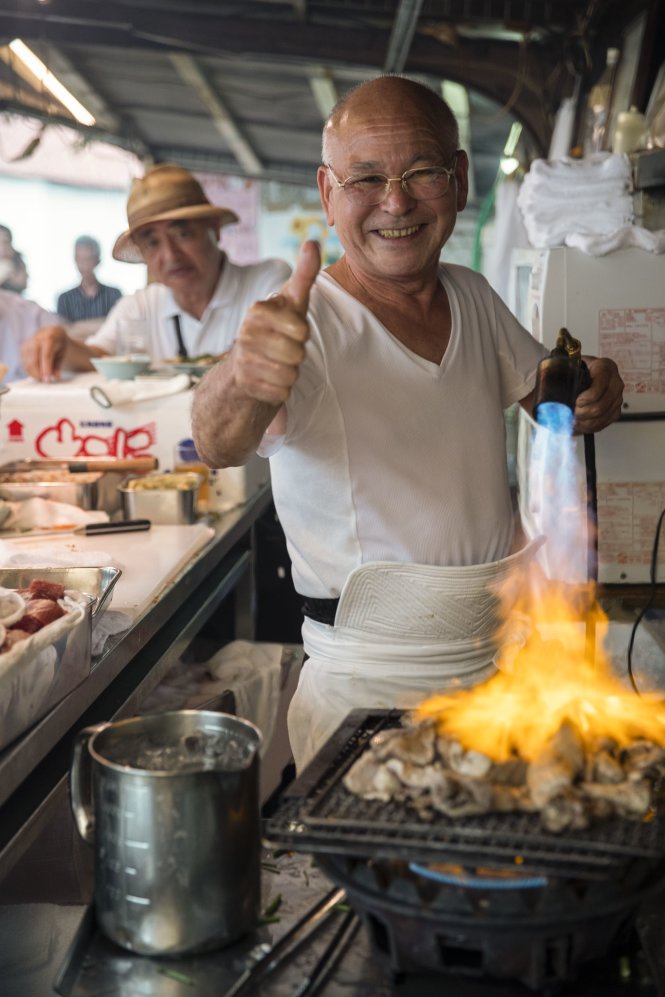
[288,537,543,772]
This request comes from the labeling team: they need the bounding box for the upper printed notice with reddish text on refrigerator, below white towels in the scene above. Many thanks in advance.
[598,307,665,394]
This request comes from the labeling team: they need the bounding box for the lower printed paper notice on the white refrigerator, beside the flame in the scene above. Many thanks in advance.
[598,481,665,581]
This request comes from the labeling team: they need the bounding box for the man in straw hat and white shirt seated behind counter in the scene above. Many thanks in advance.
[23,163,291,381]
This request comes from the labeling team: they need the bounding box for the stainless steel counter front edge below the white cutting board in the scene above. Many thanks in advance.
[0,486,271,884]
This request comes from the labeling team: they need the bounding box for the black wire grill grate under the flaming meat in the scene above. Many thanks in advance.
[266,710,665,876]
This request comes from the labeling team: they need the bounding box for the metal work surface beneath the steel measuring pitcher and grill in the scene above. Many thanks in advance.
[0,854,664,997]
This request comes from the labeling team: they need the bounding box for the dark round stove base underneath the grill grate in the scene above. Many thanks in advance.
[317,855,665,997]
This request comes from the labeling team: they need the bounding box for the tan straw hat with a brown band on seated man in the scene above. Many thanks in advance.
[113,163,238,263]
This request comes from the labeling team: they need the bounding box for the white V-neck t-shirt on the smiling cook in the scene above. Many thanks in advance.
[260,265,546,598]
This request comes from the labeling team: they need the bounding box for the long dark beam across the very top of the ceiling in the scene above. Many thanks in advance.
[0,0,574,155]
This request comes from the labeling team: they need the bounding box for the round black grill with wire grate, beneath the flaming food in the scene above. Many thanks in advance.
[265,710,665,997]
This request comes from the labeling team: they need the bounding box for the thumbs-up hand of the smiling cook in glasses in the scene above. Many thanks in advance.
[229,242,321,405]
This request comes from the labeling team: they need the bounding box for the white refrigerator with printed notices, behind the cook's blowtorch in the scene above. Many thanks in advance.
[518,247,665,584]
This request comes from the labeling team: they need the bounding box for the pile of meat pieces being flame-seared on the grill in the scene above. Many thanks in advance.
[343,719,665,832]
